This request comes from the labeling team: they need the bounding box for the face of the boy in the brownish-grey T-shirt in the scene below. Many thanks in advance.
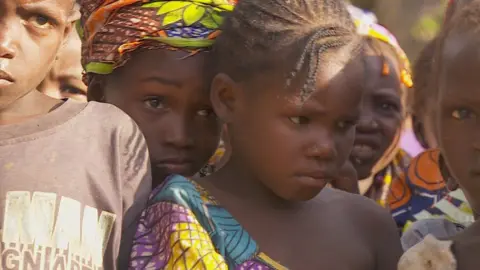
[0,0,72,109]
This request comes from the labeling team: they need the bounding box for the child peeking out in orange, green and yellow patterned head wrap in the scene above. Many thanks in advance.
[80,0,233,186]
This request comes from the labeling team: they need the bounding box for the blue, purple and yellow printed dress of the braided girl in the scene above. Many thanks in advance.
[130,175,286,270]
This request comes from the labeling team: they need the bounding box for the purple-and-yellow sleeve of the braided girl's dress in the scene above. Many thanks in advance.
[129,201,228,270]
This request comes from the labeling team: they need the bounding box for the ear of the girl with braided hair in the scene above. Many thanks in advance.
[210,73,240,124]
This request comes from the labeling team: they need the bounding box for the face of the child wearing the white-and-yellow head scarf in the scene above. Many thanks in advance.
[349,54,403,179]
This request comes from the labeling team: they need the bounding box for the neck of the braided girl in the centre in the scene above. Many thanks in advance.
[209,155,300,209]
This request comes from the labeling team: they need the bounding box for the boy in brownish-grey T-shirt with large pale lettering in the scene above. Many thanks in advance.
[0,0,151,269]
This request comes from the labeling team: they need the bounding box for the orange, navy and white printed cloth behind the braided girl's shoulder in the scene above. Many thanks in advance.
[389,149,473,230]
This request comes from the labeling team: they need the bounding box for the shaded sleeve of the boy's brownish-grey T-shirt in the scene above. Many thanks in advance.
[117,119,152,269]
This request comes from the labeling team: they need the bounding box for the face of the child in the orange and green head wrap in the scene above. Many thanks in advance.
[89,49,221,185]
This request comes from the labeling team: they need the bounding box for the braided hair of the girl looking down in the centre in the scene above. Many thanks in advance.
[211,0,359,101]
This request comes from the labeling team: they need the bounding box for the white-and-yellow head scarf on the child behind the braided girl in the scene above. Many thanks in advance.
[349,6,413,206]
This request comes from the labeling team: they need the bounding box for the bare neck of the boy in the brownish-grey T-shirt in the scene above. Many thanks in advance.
[0,90,63,125]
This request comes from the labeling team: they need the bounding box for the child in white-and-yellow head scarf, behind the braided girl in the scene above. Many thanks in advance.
[344,6,412,207]
